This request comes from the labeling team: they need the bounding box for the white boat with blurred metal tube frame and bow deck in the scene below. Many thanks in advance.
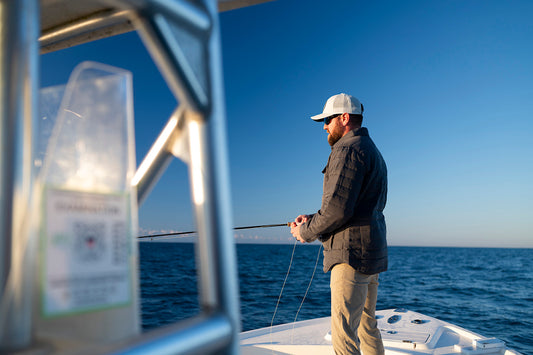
[0,0,517,354]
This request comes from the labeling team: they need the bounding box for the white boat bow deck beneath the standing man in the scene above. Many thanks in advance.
[241,309,518,355]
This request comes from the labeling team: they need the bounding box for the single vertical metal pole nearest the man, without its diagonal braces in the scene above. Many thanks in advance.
[189,0,241,354]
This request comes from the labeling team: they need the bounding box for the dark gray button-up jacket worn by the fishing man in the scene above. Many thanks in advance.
[300,127,387,275]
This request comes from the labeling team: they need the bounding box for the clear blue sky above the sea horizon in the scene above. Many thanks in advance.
[41,0,533,247]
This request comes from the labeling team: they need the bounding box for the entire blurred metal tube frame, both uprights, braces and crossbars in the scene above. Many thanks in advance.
[0,0,240,354]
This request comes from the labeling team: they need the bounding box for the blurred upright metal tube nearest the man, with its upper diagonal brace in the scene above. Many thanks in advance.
[123,1,240,354]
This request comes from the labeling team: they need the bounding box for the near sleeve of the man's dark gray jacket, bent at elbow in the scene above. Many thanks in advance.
[300,147,366,242]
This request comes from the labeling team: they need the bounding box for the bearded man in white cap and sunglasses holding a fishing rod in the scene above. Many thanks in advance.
[291,94,387,355]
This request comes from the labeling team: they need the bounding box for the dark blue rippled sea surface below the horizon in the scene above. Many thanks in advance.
[139,242,533,355]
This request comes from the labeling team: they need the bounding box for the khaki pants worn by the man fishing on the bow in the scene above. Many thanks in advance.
[330,264,385,355]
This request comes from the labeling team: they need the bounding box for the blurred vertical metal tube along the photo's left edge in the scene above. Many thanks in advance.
[0,0,40,352]
